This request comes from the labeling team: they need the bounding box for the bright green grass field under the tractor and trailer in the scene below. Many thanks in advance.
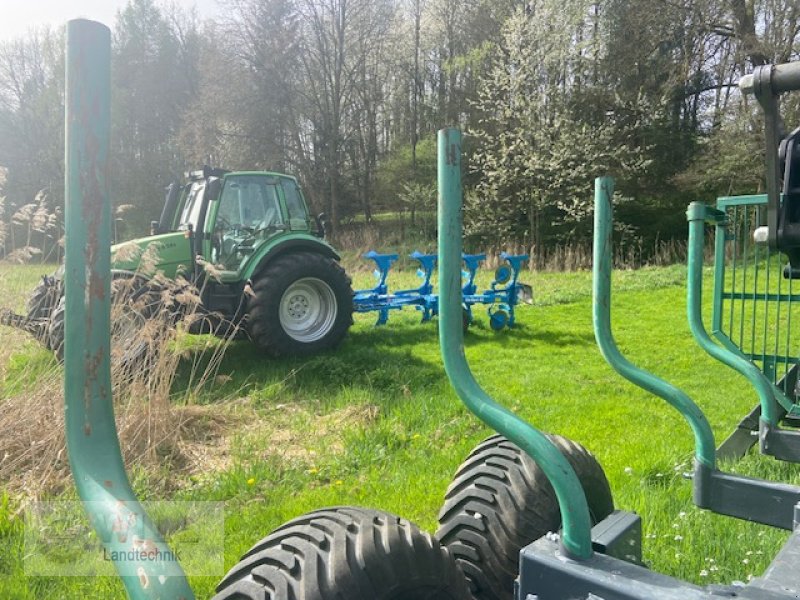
[0,266,800,599]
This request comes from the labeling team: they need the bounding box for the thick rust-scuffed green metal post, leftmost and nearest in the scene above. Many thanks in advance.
[64,19,194,600]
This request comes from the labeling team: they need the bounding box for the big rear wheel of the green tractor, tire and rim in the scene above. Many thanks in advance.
[246,252,353,356]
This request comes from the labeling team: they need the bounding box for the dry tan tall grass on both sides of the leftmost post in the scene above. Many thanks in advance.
[0,262,242,499]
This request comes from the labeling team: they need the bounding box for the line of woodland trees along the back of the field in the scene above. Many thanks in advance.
[0,0,800,257]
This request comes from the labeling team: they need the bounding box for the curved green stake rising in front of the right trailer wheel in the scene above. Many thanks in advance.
[438,129,592,559]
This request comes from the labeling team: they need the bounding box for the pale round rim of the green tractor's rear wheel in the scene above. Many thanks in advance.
[278,277,338,343]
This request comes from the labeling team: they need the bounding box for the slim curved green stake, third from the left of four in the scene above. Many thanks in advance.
[592,177,716,469]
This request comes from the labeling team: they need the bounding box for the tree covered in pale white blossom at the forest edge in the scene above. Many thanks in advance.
[466,1,647,243]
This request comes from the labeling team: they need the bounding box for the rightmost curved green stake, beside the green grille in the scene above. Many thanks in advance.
[686,202,778,426]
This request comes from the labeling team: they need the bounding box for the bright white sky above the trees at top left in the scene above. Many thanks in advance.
[0,0,221,42]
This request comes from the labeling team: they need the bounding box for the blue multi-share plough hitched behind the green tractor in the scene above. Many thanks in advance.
[353,250,533,331]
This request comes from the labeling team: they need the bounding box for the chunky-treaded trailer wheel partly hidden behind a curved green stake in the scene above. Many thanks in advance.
[436,435,614,600]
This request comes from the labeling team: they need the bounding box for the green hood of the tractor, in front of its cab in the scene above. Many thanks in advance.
[111,231,192,279]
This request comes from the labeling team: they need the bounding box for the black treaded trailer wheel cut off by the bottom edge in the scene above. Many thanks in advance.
[213,507,470,600]
